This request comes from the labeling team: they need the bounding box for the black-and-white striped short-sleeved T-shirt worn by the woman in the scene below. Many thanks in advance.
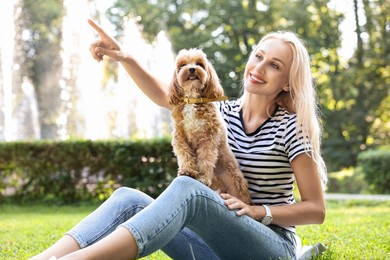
[217,99,307,231]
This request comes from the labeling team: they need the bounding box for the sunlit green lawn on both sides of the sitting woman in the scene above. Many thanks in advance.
[0,201,390,260]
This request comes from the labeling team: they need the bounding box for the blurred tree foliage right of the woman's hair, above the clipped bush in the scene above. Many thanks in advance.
[323,0,390,169]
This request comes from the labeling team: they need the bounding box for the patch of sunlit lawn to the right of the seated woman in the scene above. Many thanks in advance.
[297,201,390,259]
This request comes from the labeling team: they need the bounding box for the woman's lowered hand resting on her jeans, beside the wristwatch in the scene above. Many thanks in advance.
[220,193,265,220]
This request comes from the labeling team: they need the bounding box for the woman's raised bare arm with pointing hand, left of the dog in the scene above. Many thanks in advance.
[88,19,171,110]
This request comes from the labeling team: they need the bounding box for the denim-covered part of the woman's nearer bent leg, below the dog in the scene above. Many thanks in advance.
[122,176,295,259]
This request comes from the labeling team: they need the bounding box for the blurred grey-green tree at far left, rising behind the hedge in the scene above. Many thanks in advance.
[18,0,64,139]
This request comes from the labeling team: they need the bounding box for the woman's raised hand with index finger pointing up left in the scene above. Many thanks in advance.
[88,19,126,61]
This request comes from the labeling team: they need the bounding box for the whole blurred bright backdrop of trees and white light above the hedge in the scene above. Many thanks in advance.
[0,0,390,173]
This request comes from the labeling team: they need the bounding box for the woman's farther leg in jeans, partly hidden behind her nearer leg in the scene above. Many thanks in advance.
[32,185,216,259]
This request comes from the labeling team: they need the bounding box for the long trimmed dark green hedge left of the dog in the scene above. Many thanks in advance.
[0,139,177,203]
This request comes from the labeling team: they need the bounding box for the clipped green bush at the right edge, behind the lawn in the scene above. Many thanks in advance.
[358,149,390,194]
